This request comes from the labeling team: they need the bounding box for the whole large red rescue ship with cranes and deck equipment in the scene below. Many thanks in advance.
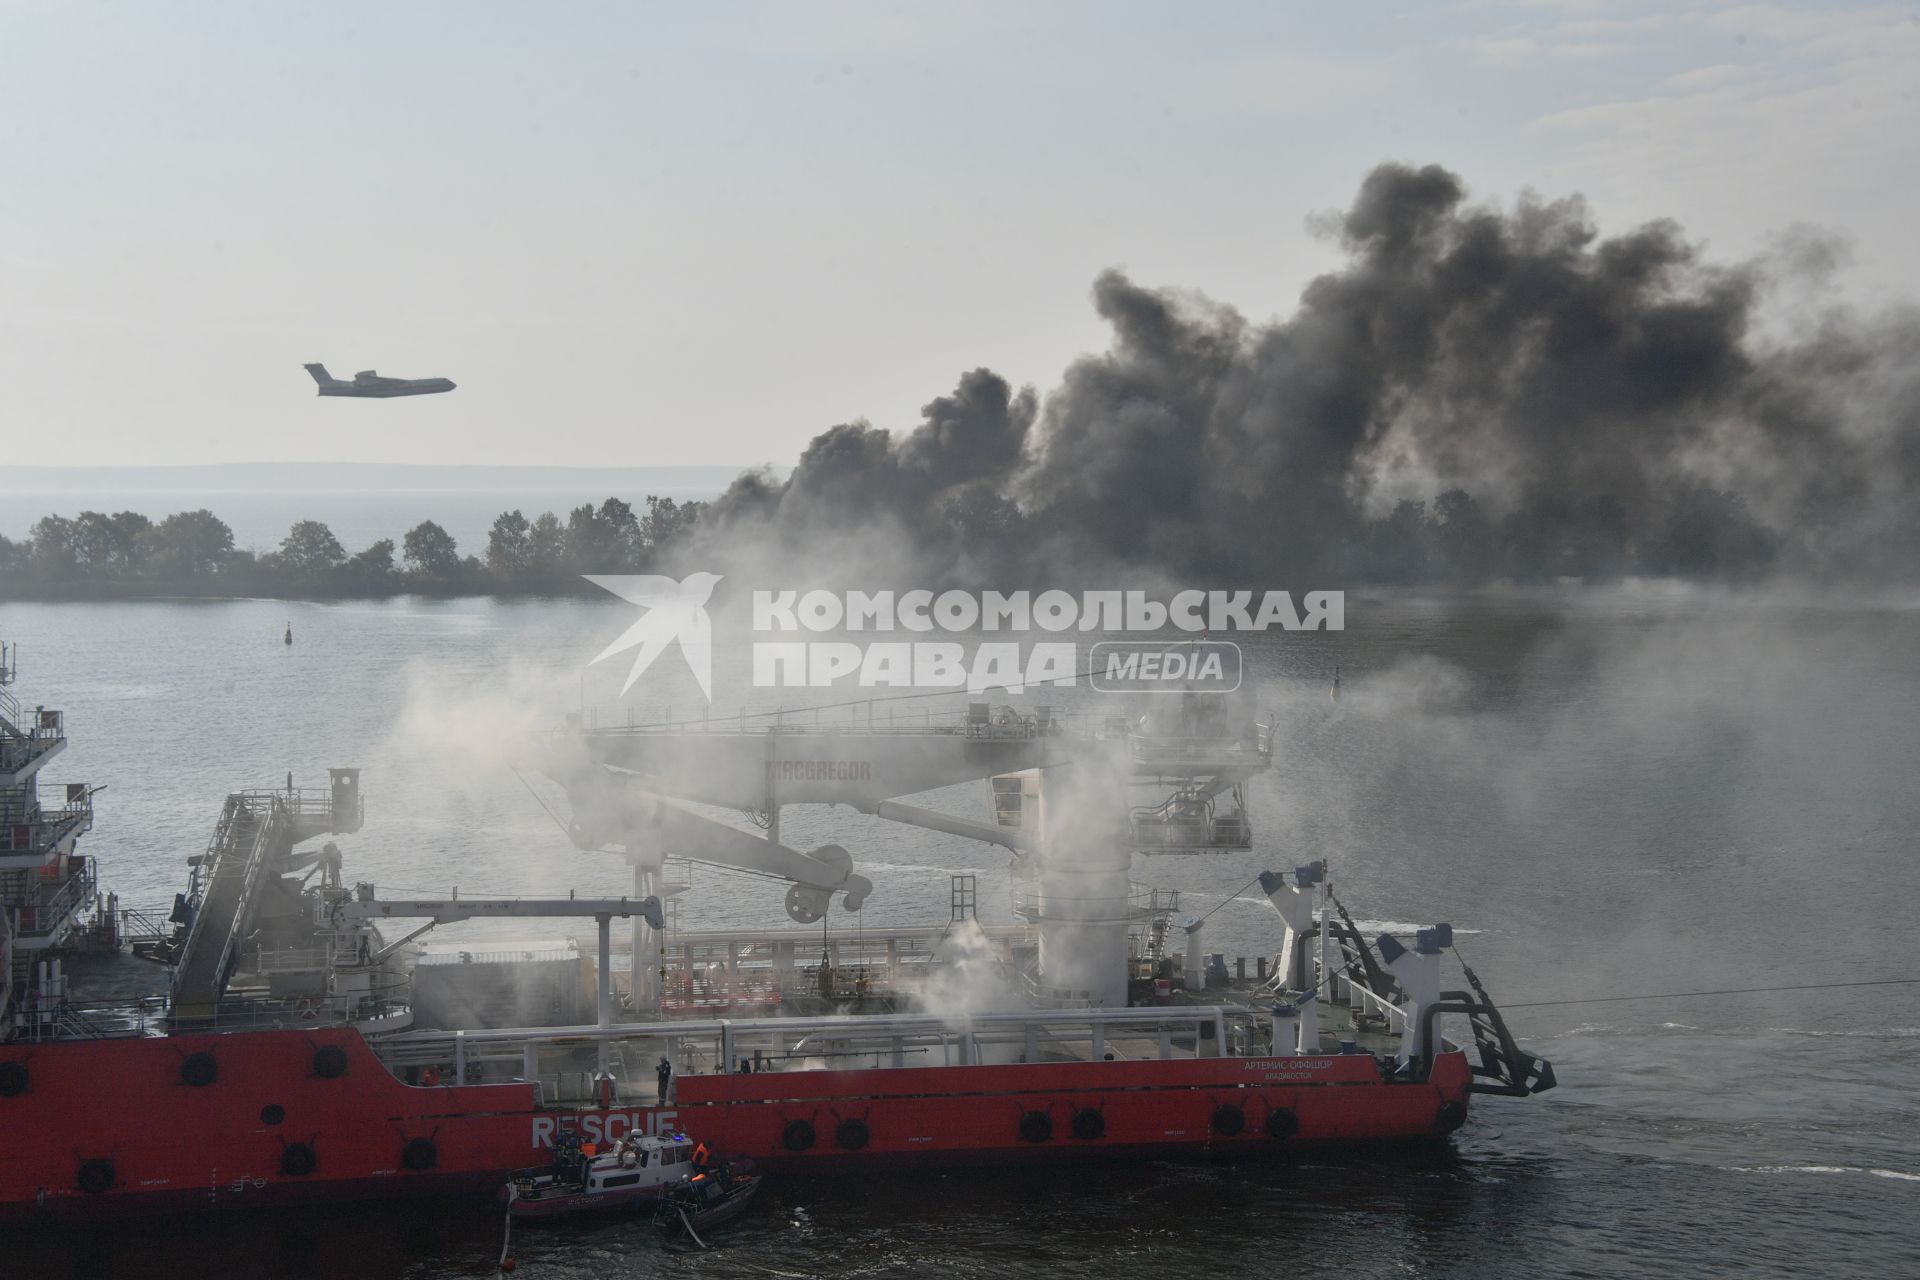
[0,644,1553,1221]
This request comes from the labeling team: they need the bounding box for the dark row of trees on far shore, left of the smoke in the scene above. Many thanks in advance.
[0,495,707,599]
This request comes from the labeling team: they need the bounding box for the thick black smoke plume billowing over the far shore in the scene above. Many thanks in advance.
[705,165,1920,585]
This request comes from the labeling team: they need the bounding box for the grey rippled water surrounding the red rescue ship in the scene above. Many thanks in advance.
[0,593,1920,1280]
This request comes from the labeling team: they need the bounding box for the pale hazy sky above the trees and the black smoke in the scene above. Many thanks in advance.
[0,0,1920,466]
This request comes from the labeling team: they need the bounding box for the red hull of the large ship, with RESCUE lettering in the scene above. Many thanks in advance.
[0,1029,1469,1221]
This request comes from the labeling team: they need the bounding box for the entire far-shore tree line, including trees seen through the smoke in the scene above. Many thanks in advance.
[0,486,1774,599]
